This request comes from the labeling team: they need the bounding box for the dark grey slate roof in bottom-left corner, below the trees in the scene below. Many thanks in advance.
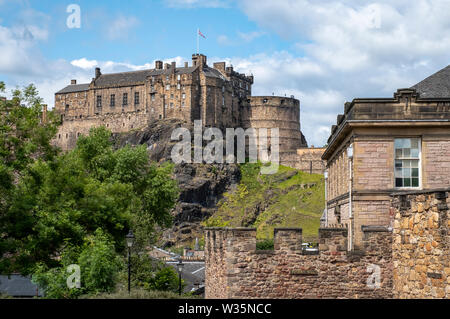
[0,274,42,297]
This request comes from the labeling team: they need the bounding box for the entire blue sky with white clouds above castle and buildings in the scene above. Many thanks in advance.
[0,0,450,145]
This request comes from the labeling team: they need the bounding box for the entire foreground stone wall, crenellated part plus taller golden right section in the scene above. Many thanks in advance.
[205,188,450,299]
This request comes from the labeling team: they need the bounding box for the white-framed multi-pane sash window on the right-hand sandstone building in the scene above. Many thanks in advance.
[394,138,420,187]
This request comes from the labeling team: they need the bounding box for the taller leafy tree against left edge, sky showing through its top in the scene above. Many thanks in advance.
[0,82,57,272]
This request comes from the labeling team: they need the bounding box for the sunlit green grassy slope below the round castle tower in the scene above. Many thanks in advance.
[204,163,325,241]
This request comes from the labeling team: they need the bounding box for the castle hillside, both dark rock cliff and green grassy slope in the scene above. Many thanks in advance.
[114,119,324,247]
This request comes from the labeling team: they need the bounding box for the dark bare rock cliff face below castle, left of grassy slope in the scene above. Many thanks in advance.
[114,119,240,247]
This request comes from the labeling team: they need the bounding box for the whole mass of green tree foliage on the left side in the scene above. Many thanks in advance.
[0,82,178,274]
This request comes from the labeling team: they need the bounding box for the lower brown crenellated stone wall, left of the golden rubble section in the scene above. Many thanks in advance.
[205,228,392,298]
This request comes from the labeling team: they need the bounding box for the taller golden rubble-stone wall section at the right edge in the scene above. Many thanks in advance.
[392,189,450,299]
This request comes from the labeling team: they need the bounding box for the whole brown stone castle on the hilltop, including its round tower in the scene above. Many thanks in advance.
[51,54,307,152]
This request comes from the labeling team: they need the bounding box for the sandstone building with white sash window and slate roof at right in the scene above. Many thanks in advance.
[322,66,450,250]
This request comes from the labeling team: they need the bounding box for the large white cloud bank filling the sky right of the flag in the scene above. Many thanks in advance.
[239,0,450,145]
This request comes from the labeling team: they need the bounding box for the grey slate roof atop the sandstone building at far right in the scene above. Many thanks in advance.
[411,65,450,98]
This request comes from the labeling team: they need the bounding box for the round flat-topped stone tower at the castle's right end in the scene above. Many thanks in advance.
[241,96,306,152]
